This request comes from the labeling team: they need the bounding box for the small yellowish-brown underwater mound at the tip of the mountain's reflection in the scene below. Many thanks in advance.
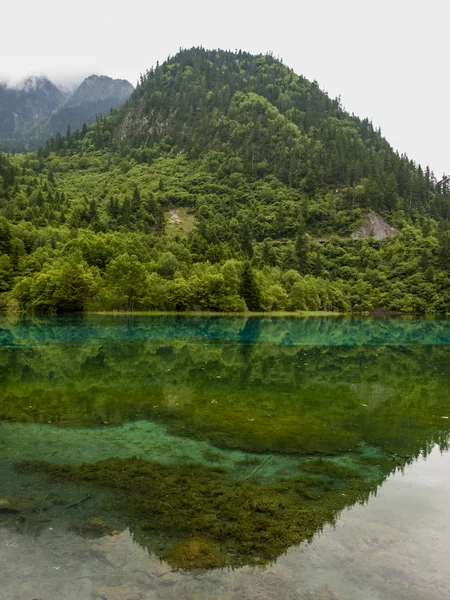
[164,537,224,571]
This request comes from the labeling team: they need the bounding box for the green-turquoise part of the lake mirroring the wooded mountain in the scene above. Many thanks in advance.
[0,317,450,598]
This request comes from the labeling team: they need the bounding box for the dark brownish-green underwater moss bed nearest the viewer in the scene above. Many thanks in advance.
[20,458,387,568]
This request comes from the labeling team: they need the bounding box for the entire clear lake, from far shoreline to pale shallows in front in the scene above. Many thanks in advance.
[0,317,450,599]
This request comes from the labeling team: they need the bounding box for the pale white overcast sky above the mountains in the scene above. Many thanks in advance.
[0,0,450,175]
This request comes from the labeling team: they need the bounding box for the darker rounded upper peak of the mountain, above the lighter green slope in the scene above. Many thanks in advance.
[104,48,447,218]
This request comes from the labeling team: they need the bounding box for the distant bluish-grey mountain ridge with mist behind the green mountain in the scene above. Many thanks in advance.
[0,75,133,152]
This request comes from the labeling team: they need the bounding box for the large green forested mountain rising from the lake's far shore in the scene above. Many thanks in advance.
[0,48,450,313]
